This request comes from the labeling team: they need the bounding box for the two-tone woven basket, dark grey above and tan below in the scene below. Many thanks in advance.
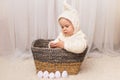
[31,39,87,75]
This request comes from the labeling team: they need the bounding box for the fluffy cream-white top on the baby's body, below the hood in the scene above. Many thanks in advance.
[55,30,87,54]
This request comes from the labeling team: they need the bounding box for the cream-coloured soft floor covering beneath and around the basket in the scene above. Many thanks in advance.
[0,53,120,80]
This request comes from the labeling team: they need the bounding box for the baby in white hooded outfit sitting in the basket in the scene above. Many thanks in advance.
[49,2,87,54]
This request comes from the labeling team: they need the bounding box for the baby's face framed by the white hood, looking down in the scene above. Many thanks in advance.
[59,18,74,36]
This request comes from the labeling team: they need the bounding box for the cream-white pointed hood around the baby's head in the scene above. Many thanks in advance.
[58,0,80,33]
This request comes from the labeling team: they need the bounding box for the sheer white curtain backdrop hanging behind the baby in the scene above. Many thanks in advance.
[0,0,120,55]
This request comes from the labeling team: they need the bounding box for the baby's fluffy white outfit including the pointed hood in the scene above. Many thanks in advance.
[51,2,87,54]
